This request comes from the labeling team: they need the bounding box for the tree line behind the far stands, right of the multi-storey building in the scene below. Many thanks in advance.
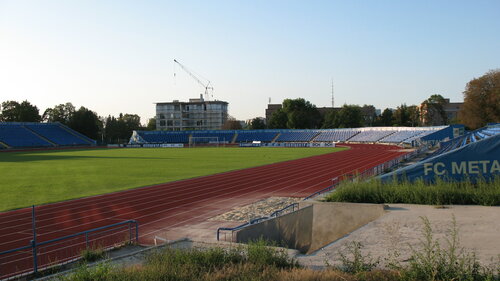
[262,70,500,129]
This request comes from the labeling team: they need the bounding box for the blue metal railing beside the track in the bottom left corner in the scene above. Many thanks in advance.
[0,217,139,279]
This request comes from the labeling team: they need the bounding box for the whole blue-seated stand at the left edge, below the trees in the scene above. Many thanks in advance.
[0,122,95,148]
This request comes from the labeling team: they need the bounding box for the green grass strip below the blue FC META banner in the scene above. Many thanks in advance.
[325,176,500,206]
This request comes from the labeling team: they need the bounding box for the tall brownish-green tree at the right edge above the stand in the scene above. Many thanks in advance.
[458,69,500,129]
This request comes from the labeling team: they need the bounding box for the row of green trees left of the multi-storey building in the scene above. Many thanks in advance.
[0,100,156,143]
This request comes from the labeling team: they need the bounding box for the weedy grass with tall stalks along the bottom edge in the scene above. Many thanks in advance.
[59,224,500,281]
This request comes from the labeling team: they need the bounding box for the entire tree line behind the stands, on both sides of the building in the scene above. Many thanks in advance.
[0,69,500,137]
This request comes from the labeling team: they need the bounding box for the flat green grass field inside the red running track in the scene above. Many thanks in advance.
[0,147,343,211]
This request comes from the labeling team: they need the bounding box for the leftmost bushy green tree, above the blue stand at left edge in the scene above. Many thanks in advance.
[0,100,42,122]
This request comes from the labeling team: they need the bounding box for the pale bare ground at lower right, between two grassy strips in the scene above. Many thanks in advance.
[297,204,500,268]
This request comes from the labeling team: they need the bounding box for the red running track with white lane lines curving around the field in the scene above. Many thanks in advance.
[0,144,405,278]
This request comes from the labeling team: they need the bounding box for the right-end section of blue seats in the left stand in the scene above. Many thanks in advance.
[25,123,89,146]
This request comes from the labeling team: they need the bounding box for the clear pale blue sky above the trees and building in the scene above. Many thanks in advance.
[0,0,500,123]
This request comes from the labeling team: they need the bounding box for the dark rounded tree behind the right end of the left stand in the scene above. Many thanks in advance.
[68,106,102,140]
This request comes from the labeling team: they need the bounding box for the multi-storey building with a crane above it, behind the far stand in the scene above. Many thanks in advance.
[156,95,228,131]
